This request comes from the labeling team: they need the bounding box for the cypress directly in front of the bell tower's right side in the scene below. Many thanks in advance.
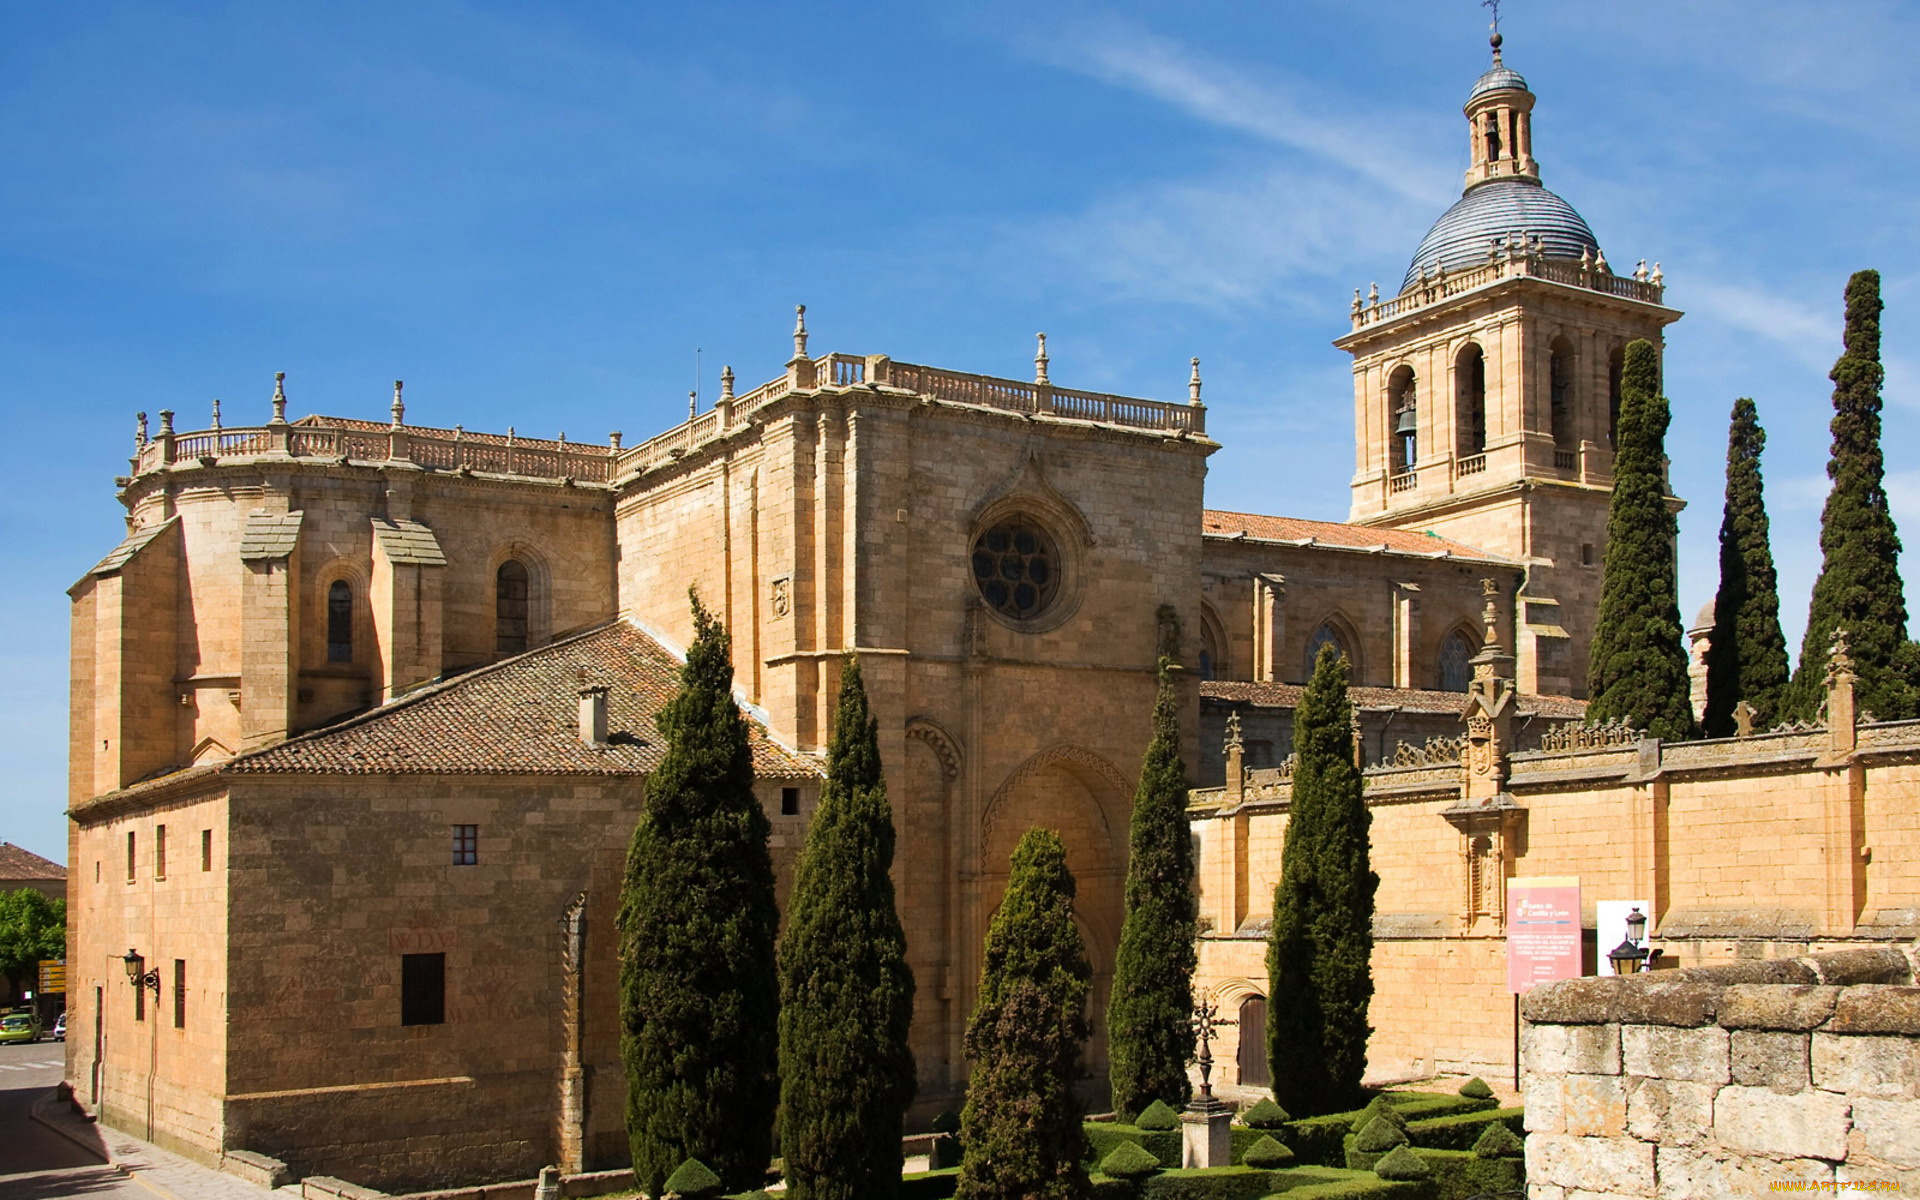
[1586,338,1693,739]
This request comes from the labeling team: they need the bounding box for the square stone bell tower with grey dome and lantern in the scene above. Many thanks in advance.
[1334,33,1680,695]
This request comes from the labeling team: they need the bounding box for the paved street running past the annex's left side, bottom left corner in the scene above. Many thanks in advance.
[0,1043,280,1200]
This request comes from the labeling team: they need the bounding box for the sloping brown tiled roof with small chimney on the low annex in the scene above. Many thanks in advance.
[221,620,820,780]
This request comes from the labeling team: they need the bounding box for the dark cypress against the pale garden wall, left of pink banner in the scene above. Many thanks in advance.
[1267,645,1380,1116]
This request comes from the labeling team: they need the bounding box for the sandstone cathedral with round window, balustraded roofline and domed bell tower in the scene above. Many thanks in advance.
[67,28,1680,1190]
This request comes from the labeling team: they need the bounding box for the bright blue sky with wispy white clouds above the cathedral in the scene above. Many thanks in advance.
[0,0,1920,858]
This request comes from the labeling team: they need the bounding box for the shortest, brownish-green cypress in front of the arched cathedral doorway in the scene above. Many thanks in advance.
[956,829,1092,1200]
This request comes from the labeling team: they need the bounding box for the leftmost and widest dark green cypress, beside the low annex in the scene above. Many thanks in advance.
[620,597,780,1196]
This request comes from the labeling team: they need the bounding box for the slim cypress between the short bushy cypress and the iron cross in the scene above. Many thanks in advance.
[1106,659,1198,1121]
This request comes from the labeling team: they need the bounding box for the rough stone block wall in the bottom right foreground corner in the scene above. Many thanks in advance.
[1521,945,1920,1200]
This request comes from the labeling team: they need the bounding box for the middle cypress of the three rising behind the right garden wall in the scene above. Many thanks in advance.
[1701,397,1788,737]
